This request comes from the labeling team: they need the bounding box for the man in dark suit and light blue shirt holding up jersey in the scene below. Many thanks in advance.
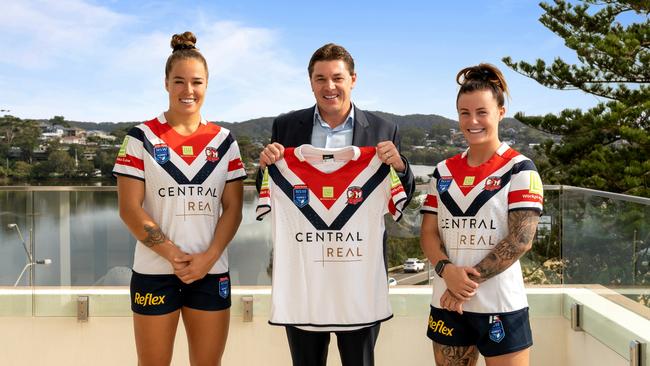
[257,43,415,366]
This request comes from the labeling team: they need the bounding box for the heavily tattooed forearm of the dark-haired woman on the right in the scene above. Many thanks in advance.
[470,210,539,282]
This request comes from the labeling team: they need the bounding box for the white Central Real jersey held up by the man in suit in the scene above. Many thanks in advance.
[257,145,406,331]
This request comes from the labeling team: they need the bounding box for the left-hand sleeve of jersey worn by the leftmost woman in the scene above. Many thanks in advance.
[113,127,146,181]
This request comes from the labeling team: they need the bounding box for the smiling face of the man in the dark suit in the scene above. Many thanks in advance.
[310,60,357,127]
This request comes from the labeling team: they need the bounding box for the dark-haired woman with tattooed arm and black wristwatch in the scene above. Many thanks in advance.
[420,64,543,366]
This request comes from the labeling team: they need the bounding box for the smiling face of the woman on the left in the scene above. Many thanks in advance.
[165,58,208,118]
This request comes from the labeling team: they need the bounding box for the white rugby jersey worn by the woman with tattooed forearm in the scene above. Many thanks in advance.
[421,144,543,313]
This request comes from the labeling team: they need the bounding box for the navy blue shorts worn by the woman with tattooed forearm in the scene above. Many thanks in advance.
[427,306,533,357]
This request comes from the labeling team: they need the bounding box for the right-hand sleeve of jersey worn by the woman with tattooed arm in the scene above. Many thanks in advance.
[508,161,544,214]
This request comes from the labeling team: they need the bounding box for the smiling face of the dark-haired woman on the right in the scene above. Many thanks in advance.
[457,89,506,150]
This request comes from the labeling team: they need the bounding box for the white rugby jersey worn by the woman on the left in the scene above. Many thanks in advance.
[113,113,246,274]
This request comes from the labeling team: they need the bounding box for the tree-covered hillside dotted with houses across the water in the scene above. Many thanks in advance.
[0,112,554,186]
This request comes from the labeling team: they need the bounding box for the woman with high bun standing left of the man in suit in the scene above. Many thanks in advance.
[113,32,246,366]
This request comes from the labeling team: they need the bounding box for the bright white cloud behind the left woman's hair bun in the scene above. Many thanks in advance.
[105,21,313,121]
